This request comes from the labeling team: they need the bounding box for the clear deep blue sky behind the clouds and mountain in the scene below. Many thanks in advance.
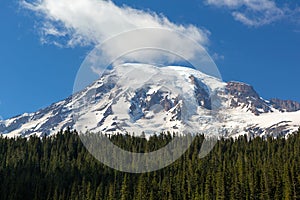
[0,0,300,118]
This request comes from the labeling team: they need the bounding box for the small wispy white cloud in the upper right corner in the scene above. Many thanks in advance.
[206,0,297,27]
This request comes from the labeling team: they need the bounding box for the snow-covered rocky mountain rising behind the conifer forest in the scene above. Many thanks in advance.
[0,64,300,137]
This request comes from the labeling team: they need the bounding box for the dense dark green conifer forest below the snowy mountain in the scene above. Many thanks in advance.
[0,130,300,200]
